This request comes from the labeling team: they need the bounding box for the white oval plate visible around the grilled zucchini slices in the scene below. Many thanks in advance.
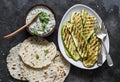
[58,4,109,69]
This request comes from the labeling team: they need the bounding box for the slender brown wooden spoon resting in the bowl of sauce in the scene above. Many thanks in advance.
[3,13,40,39]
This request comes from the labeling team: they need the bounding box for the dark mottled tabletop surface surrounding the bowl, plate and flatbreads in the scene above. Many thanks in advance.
[0,0,120,82]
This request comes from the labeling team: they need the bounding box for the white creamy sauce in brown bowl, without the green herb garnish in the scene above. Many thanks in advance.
[26,6,55,35]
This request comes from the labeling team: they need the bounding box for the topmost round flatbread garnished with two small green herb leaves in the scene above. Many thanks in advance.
[19,37,56,68]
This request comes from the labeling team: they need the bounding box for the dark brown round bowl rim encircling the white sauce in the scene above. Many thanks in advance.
[24,4,58,37]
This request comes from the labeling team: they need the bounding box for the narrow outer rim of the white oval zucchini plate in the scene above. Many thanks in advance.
[58,4,110,70]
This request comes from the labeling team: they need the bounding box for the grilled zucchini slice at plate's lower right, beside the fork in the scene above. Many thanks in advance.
[83,33,101,67]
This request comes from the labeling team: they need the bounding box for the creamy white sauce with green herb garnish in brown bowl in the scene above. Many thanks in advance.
[26,6,56,35]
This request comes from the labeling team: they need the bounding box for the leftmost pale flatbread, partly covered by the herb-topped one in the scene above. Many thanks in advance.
[6,43,26,80]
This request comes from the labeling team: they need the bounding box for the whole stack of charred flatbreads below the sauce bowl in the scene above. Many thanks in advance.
[7,37,70,82]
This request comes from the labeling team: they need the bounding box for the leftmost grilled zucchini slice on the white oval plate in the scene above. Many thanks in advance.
[62,23,80,61]
